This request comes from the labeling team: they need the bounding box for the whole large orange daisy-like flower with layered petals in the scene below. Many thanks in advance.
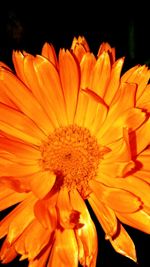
[0,37,150,267]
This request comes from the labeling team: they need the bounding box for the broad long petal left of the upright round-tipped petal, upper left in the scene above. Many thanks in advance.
[32,56,67,128]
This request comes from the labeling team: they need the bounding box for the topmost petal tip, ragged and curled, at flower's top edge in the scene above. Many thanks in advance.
[71,36,90,62]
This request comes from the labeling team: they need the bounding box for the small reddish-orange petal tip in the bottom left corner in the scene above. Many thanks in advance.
[0,239,17,264]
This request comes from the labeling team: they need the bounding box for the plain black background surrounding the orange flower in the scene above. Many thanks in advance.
[0,1,150,267]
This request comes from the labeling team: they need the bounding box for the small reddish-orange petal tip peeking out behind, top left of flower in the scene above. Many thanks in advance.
[41,43,58,68]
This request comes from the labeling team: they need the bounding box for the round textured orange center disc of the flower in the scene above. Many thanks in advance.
[41,125,108,198]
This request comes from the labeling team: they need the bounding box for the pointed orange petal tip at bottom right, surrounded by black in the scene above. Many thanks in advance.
[110,225,137,262]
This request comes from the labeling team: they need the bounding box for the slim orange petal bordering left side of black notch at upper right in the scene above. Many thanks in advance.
[104,58,124,105]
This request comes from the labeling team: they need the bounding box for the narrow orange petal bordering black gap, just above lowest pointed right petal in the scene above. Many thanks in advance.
[88,193,118,239]
